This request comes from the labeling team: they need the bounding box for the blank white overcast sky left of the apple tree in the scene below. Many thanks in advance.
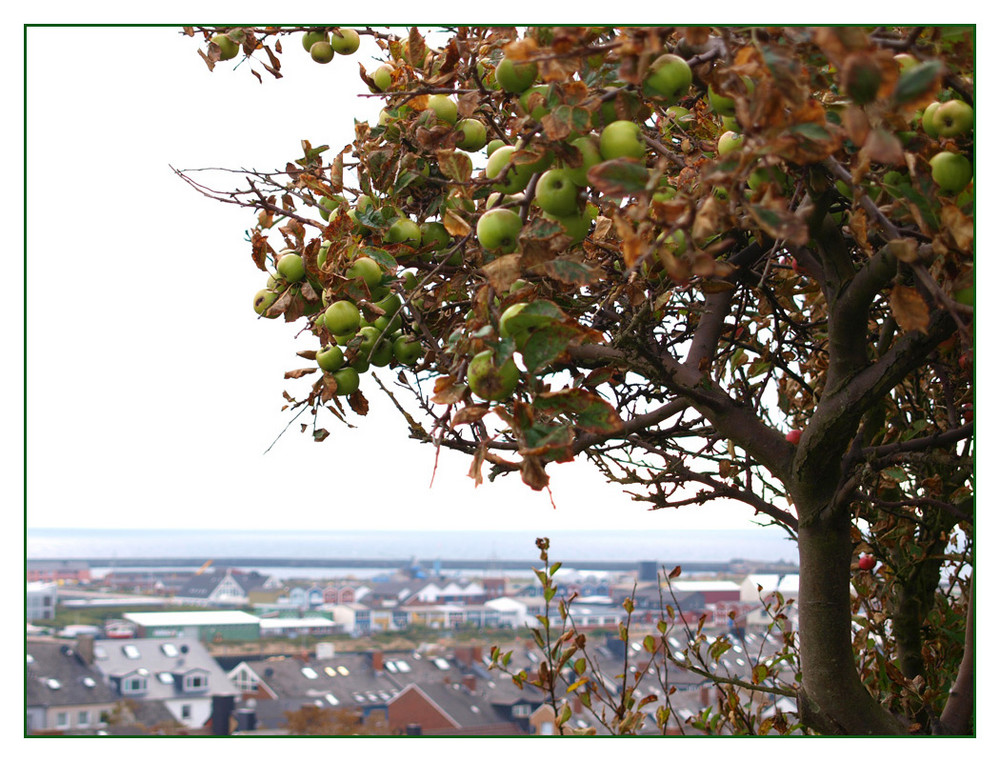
[15,16,982,540]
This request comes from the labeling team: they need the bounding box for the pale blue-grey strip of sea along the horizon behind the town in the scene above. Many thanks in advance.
[26,527,798,578]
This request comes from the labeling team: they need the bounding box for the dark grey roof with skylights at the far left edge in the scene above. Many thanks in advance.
[26,640,118,706]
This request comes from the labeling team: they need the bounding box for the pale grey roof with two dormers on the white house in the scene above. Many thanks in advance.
[94,638,238,700]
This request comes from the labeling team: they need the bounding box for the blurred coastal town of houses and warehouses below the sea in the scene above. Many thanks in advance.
[26,560,798,736]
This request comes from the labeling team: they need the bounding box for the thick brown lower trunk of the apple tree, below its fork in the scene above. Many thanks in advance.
[799,511,906,735]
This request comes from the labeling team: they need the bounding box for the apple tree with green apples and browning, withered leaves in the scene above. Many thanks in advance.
[181,26,974,734]
